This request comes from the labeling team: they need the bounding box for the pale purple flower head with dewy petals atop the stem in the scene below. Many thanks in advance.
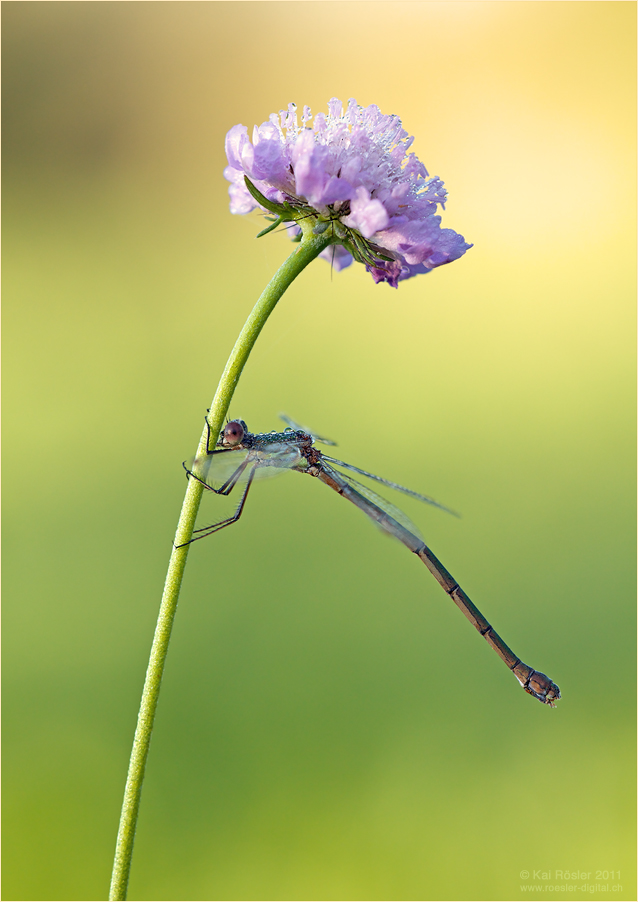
[224,98,472,288]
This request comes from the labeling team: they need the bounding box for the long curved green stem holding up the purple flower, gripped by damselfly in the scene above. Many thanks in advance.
[109,228,332,899]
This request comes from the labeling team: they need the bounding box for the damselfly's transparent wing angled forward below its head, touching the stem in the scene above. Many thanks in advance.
[185,443,301,488]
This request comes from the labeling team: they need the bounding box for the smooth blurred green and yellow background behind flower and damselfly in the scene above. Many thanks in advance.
[3,2,636,900]
